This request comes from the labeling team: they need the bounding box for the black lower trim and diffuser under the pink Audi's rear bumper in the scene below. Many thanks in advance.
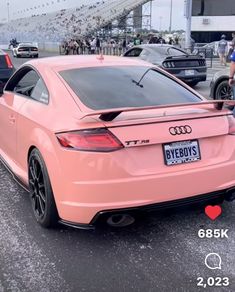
[60,186,235,230]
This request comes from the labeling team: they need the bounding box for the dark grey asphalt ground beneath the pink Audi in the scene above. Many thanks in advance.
[0,50,235,292]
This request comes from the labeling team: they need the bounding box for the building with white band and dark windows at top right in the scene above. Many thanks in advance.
[192,0,235,43]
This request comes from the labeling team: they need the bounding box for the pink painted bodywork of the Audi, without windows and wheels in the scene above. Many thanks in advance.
[0,56,235,226]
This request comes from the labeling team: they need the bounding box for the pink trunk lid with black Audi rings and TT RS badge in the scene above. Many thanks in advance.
[103,109,229,147]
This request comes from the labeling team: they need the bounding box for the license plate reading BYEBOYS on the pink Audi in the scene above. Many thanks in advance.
[163,140,201,165]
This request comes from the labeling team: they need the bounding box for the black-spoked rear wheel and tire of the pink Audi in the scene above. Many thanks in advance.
[28,148,58,228]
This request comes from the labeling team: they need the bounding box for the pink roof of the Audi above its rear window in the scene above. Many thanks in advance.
[25,55,152,72]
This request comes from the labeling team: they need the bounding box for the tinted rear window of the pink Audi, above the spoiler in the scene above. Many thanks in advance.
[60,66,201,110]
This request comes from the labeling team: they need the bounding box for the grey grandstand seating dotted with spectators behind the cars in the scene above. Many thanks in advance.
[0,0,150,43]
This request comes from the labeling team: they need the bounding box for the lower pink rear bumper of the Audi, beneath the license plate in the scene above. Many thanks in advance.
[55,156,235,224]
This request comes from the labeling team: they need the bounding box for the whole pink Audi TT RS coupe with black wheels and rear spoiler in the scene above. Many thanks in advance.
[0,55,235,228]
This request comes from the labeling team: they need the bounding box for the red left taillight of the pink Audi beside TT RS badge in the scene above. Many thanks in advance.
[56,129,123,152]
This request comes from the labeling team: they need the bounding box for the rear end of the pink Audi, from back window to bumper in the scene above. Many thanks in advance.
[51,61,235,226]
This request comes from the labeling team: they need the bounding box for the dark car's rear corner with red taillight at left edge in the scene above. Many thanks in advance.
[0,50,15,88]
